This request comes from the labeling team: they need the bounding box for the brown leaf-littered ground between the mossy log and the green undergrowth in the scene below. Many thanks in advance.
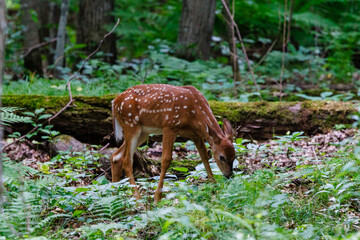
[3,129,357,185]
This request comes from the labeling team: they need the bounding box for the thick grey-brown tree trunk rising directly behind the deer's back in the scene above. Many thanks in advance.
[177,0,216,60]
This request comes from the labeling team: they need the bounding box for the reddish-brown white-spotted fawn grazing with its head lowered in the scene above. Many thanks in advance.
[111,84,235,204]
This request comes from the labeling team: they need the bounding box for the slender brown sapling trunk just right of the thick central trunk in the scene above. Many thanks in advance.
[222,0,241,98]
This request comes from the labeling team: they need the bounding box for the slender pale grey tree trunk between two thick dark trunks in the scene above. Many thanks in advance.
[54,0,69,78]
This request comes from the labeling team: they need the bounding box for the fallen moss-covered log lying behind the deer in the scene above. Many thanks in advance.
[2,95,356,144]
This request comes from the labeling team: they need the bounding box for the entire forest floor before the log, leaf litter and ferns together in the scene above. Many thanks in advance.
[0,129,360,239]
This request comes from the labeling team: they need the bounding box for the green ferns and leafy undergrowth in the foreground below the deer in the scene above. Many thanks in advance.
[0,130,360,239]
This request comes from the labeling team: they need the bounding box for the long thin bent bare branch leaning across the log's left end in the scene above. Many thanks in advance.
[2,18,120,152]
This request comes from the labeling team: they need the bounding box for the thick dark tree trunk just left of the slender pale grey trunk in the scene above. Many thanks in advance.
[21,0,43,74]
